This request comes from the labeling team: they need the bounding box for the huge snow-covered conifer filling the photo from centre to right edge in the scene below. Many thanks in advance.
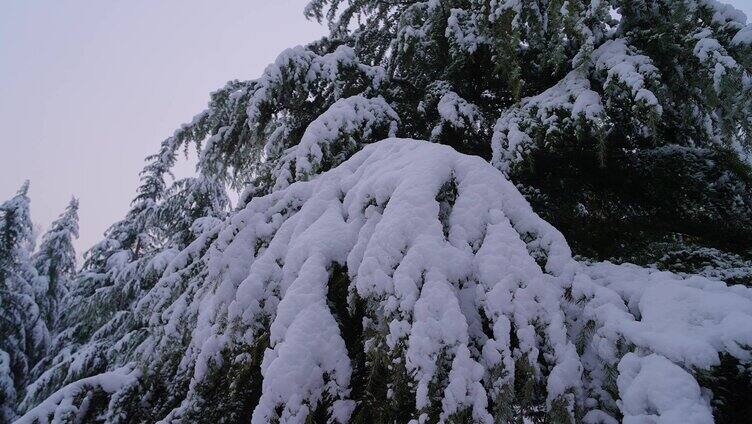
[14,0,752,424]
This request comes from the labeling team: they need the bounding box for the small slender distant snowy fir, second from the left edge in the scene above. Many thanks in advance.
[32,198,78,330]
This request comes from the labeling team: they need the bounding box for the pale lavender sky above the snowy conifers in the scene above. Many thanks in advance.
[0,0,752,253]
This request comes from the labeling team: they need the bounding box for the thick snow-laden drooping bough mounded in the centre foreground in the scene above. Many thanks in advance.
[16,139,752,424]
